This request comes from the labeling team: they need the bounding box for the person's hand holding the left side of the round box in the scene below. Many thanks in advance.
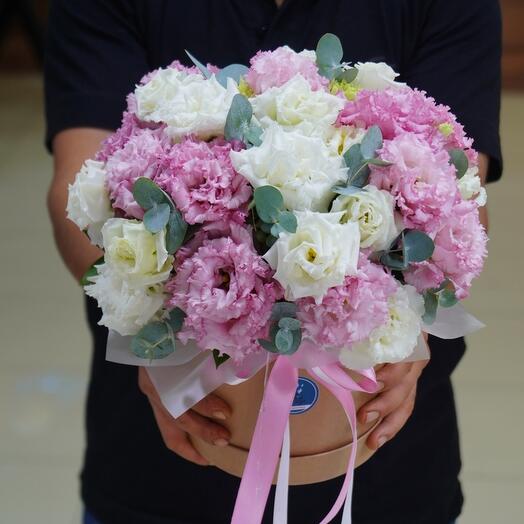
[138,368,231,466]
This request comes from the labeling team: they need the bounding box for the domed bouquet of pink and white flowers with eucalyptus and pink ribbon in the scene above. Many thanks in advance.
[67,34,487,522]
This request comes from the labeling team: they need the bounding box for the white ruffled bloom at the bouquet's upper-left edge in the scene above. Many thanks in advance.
[135,68,238,140]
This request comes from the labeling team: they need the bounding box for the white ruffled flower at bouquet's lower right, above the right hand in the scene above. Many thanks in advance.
[340,284,424,369]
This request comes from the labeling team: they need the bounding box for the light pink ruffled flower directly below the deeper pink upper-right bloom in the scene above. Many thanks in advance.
[370,133,460,233]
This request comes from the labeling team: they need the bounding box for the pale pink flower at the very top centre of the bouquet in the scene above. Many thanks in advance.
[246,46,329,94]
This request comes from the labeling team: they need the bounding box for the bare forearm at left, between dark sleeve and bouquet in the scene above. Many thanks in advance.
[47,128,109,280]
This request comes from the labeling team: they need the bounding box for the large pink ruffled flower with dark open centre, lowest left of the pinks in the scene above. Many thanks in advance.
[166,223,283,362]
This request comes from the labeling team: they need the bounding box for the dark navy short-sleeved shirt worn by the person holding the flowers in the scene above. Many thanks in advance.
[45,0,502,524]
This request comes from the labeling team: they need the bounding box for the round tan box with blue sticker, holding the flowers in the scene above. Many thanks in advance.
[192,369,377,485]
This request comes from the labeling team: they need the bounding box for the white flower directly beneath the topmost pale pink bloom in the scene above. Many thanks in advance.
[251,75,344,136]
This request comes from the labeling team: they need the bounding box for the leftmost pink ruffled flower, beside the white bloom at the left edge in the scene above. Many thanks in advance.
[106,126,171,219]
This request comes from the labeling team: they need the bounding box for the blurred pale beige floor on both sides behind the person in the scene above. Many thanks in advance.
[0,76,524,524]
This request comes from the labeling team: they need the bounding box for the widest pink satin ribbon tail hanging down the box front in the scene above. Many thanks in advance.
[231,357,298,524]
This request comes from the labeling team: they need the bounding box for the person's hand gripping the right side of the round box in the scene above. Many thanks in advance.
[358,360,429,449]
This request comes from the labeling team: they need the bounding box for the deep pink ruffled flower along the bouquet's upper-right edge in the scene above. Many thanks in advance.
[337,87,474,152]
